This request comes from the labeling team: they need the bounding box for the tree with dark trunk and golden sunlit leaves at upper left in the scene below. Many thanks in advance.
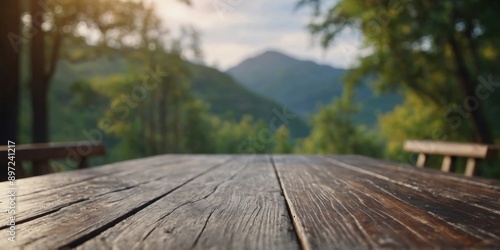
[25,0,152,146]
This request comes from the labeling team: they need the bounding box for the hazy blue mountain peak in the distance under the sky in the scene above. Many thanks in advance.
[227,51,402,127]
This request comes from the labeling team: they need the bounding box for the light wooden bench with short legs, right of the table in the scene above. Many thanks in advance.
[404,141,499,176]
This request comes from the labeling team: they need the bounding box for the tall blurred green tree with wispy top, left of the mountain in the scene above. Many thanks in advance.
[79,2,198,155]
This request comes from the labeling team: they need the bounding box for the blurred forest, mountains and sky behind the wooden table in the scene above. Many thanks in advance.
[0,0,500,178]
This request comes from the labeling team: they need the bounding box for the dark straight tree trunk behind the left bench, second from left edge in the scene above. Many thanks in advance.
[30,0,50,175]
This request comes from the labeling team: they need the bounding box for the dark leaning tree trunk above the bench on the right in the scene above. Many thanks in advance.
[449,34,493,144]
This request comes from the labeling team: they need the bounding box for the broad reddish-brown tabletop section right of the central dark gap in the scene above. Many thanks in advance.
[274,156,500,249]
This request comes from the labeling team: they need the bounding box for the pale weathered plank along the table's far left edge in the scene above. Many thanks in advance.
[0,156,191,225]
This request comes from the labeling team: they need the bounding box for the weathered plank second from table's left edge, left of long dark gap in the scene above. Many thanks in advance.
[0,156,228,249]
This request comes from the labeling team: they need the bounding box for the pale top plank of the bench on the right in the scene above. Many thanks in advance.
[404,141,499,159]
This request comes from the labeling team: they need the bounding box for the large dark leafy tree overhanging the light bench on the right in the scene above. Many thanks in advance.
[299,0,500,143]
